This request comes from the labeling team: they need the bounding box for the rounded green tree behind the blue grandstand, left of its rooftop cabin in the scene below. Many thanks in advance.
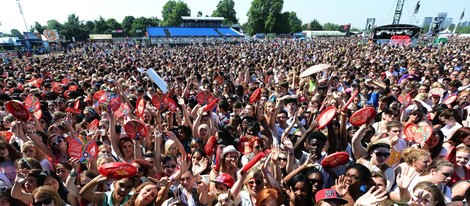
[162,0,191,26]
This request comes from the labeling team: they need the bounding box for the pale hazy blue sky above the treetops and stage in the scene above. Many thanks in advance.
[0,0,470,33]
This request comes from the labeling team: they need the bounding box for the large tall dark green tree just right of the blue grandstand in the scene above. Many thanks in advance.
[246,0,284,35]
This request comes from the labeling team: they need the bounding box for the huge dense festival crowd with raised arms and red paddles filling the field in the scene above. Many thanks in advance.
[0,37,470,206]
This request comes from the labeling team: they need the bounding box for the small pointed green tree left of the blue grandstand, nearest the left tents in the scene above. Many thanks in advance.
[60,14,89,41]
